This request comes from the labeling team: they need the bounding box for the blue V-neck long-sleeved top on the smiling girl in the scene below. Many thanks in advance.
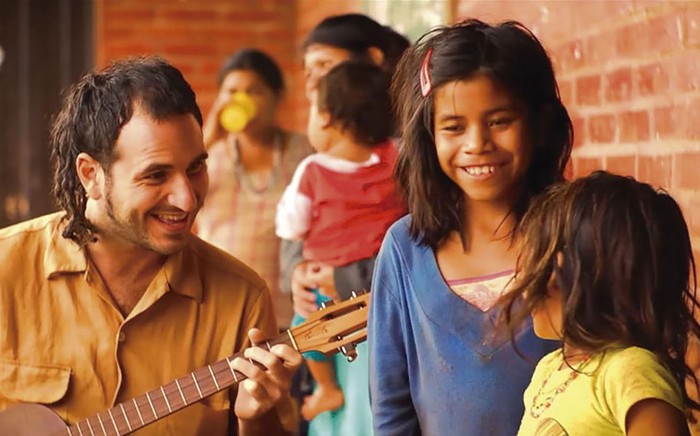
[368,216,559,436]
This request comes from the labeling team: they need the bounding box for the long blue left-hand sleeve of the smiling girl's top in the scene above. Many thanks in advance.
[367,232,421,436]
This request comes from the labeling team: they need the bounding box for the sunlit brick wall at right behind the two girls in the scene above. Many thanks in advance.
[455,0,700,258]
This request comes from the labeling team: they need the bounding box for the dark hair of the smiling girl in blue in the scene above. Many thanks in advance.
[392,19,573,249]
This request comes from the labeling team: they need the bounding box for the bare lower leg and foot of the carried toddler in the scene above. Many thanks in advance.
[301,359,345,421]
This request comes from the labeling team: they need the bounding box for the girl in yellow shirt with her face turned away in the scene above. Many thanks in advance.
[501,172,700,436]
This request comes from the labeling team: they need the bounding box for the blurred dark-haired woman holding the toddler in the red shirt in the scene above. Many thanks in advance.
[281,14,409,435]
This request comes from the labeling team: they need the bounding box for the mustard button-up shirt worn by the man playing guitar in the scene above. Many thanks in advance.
[0,214,276,435]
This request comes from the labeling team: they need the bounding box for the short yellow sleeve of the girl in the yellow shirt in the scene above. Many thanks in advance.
[603,347,684,432]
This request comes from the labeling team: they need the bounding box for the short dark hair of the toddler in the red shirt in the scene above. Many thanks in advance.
[316,61,393,145]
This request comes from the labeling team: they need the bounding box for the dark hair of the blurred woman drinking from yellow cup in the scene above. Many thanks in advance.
[217,48,284,97]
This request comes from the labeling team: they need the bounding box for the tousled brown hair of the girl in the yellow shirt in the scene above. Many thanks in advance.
[501,171,700,409]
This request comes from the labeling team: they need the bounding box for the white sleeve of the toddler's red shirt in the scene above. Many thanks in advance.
[275,160,311,240]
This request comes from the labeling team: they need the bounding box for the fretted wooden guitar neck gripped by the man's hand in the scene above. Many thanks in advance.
[64,330,298,436]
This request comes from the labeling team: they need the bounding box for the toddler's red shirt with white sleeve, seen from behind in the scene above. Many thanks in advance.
[276,142,406,266]
